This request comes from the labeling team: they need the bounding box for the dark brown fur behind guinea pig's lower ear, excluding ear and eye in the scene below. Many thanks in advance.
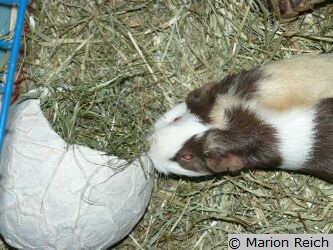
[203,107,281,171]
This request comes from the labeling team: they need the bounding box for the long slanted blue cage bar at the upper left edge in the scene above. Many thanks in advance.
[0,0,29,153]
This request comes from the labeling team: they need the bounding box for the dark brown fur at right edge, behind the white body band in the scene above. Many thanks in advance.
[303,98,333,183]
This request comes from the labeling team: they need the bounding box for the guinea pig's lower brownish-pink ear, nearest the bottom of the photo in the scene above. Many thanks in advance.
[205,153,247,173]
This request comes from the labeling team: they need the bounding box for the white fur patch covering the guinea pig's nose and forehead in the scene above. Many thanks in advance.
[148,109,209,176]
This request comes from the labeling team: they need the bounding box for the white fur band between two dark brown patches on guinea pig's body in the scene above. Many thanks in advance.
[265,106,315,170]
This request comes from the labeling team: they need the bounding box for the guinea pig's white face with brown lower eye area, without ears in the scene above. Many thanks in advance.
[148,114,209,176]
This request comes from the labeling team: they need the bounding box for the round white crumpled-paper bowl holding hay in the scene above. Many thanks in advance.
[0,100,152,250]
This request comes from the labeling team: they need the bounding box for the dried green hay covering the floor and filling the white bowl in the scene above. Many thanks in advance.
[16,0,333,249]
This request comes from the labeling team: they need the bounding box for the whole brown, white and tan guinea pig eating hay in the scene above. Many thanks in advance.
[149,54,333,181]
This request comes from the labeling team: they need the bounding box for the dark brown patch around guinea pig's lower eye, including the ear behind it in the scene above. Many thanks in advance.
[172,104,281,173]
